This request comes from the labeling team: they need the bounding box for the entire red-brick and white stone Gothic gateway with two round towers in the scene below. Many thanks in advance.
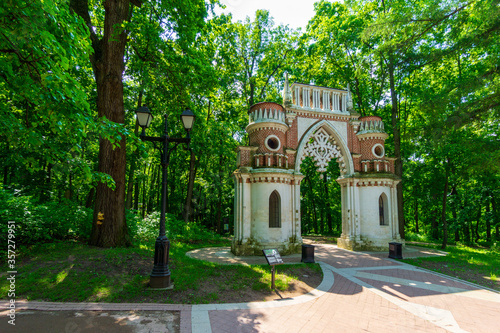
[232,80,401,255]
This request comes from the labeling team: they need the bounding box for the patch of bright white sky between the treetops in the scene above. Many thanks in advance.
[216,0,319,31]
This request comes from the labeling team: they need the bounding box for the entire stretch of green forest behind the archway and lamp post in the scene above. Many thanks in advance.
[0,0,500,246]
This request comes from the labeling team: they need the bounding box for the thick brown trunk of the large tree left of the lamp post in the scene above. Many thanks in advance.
[70,0,130,247]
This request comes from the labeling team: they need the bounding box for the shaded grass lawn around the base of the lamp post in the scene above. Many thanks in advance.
[0,241,322,304]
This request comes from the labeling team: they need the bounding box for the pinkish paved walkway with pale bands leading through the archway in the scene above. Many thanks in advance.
[0,245,500,333]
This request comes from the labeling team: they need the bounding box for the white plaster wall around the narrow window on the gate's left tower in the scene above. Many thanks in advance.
[251,183,293,244]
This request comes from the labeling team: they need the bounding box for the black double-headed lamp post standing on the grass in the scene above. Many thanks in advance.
[136,106,195,289]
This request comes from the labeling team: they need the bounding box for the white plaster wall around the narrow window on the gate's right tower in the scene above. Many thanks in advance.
[359,186,393,241]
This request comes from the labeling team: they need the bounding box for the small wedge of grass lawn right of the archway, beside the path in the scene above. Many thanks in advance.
[402,244,500,291]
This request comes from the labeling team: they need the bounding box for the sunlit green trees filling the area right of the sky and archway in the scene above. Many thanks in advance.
[299,0,500,243]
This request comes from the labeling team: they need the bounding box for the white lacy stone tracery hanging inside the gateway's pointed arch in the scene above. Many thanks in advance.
[302,128,346,174]
